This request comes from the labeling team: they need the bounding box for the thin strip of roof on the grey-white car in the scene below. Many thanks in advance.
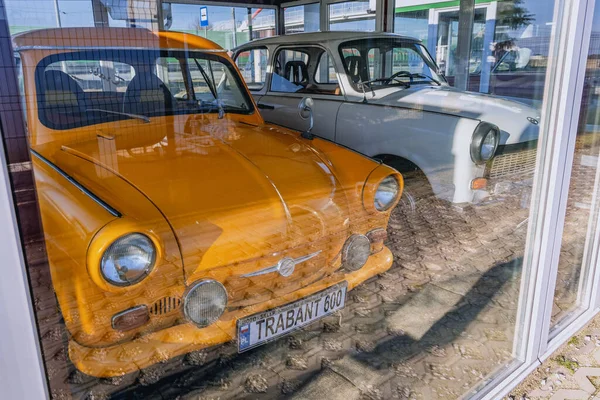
[236,31,420,50]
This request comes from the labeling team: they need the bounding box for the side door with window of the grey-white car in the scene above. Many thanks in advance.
[255,46,344,141]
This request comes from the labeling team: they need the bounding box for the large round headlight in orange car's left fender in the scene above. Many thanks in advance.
[100,233,156,286]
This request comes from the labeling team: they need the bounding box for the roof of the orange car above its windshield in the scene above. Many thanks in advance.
[12,28,225,52]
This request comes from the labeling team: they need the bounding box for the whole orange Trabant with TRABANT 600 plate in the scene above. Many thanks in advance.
[13,28,403,377]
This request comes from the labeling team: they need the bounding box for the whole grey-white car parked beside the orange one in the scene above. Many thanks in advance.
[234,32,539,204]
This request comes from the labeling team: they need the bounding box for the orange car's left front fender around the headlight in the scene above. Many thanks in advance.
[33,153,184,346]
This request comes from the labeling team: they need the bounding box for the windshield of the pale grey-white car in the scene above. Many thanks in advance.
[340,38,445,90]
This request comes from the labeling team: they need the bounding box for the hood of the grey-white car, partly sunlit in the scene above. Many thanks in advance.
[367,85,540,145]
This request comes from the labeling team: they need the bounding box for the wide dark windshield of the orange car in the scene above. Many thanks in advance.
[36,49,253,129]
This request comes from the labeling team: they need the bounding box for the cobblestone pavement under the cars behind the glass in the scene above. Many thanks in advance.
[27,136,600,400]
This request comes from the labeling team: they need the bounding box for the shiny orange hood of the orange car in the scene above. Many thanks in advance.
[43,116,360,276]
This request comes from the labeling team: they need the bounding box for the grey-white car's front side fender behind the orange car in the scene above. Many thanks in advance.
[336,103,483,203]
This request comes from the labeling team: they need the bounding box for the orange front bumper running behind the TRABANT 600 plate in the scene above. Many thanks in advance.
[69,246,393,378]
